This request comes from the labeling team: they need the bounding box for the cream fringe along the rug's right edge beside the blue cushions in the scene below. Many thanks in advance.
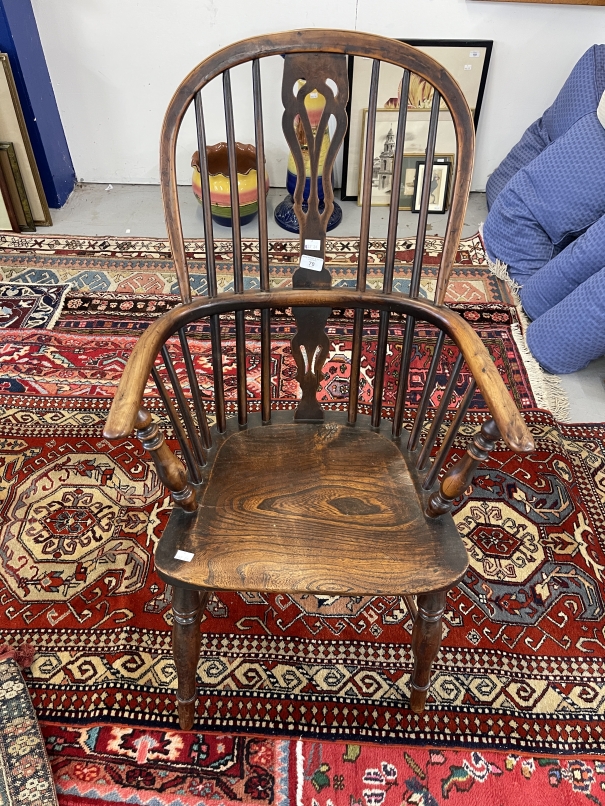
[479,224,571,423]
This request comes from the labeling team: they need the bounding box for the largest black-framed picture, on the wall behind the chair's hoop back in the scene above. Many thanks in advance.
[341,39,493,200]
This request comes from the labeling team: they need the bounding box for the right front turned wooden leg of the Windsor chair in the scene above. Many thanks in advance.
[410,591,446,714]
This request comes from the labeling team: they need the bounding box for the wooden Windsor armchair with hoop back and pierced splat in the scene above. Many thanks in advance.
[104,30,533,729]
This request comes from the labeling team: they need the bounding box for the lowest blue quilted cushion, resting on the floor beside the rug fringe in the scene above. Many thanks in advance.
[527,267,605,374]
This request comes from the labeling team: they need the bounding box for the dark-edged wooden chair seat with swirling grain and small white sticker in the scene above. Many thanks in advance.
[155,423,468,595]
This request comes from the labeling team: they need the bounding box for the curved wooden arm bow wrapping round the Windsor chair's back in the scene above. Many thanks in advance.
[104,288,534,453]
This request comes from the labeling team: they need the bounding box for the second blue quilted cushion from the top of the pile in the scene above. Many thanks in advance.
[484,112,605,284]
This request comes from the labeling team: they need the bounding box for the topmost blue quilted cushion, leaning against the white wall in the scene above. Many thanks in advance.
[486,45,605,210]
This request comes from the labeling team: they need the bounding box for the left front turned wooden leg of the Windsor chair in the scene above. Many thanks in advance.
[172,587,210,730]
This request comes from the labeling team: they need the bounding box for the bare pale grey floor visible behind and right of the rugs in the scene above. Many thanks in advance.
[47,184,605,423]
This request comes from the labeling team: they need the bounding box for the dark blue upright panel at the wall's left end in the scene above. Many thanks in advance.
[0,0,76,207]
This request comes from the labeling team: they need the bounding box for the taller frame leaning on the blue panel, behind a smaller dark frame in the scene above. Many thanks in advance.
[0,53,52,227]
